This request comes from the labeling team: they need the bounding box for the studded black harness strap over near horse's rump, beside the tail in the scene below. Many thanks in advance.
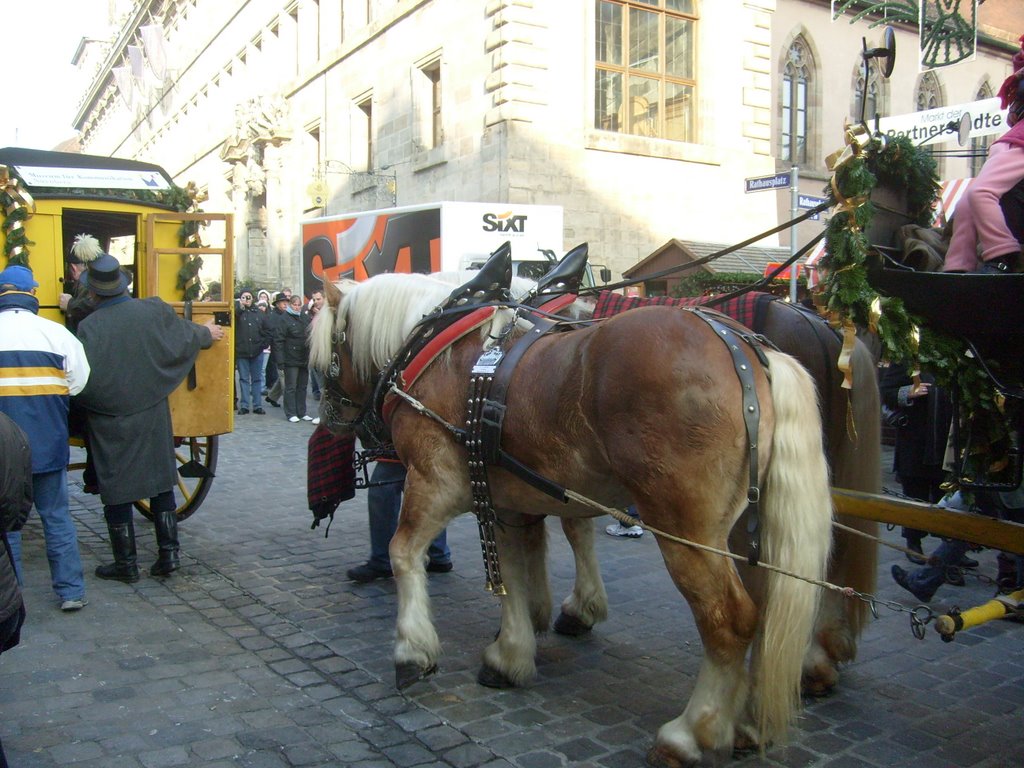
[690,308,768,565]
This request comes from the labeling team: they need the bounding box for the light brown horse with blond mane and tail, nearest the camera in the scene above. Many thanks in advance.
[310,274,831,765]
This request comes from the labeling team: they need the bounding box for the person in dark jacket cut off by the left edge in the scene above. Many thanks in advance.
[0,414,32,766]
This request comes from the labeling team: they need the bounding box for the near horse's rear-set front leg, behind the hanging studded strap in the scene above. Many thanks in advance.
[476,512,551,688]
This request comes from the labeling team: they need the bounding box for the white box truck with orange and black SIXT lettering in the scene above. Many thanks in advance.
[300,202,593,295]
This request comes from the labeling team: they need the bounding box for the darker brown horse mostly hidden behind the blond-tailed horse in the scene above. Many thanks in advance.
[548,294,882,695]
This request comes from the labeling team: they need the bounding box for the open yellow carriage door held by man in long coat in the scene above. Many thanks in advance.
[141,212,234,437]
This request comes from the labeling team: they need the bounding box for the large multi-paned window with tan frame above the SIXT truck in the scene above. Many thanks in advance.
[594,0,697,141]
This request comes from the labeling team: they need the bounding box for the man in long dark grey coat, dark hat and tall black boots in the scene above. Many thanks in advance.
[78,254,224,583]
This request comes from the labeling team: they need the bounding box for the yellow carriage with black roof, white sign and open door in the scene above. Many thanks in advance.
[0,147,234,519]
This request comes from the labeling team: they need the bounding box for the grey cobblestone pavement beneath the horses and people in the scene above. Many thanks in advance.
[0,402,1024,768]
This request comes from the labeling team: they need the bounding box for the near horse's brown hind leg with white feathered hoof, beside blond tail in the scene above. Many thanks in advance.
[648,536,758,766]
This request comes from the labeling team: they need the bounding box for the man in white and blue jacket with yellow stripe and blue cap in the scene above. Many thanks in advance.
[0,265,89,611]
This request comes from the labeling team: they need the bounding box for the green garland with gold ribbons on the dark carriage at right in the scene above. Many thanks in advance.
[816,138,1018,481]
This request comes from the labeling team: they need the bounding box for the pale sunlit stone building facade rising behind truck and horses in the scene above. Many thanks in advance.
[76,0,1024,286]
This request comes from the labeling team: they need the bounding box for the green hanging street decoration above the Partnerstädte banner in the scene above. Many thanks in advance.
[831,0,978,70]
